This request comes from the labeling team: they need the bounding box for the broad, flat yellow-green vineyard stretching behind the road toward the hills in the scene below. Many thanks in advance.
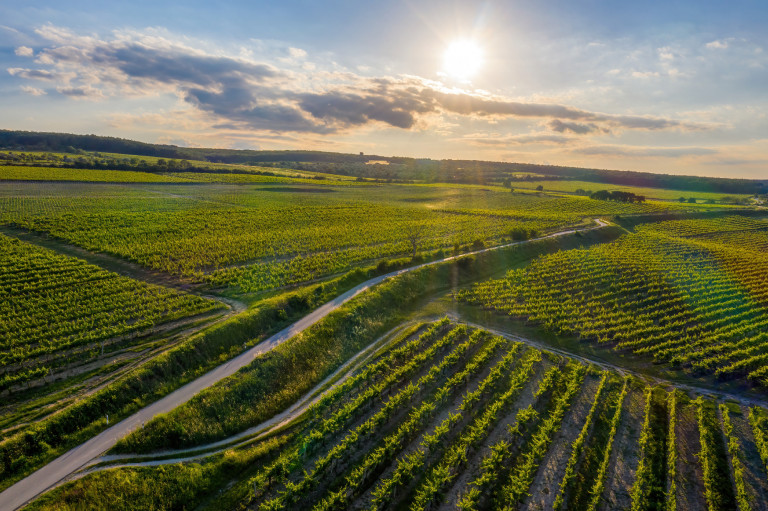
[0,179,712,293]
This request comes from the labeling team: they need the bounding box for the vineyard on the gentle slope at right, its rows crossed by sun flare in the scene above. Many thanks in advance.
[458,216,768,386]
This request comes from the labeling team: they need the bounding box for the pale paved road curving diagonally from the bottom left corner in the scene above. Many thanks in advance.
[0,219,608,511]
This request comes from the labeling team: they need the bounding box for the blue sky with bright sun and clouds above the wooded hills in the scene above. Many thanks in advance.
[0,0,768,179]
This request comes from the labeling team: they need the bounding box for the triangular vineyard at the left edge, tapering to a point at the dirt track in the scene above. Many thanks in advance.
[0,235,220,391]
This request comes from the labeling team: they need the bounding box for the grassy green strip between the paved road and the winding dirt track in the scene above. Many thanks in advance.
[115,228,612,452]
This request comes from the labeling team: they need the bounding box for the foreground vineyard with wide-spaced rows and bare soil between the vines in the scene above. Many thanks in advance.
[29,319,768,510]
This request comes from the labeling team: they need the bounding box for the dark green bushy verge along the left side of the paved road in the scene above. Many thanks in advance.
[0,286,344,487]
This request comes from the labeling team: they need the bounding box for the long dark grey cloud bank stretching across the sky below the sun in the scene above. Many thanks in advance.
[8,25,704,135]
